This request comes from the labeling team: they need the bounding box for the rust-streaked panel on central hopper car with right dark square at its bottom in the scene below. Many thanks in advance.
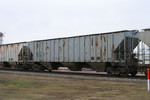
[96,35,101,62]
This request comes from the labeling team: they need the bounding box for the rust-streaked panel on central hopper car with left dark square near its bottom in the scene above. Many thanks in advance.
[91,36,96,62]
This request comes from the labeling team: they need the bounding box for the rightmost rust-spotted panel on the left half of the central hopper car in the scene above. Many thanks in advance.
[58,39,64,62]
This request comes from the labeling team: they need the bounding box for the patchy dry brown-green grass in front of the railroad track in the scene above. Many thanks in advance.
[0,73,150,100]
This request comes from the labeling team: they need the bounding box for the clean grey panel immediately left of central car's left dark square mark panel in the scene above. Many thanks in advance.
[85,36,91,62]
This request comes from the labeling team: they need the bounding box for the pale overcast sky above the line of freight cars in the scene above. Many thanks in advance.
[0,0,150,43]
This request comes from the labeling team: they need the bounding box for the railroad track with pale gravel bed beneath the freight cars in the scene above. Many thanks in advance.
[0,69,146,82]
